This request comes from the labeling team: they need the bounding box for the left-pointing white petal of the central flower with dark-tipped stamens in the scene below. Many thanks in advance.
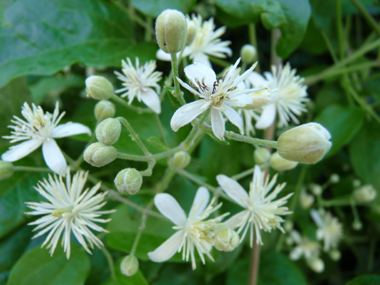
[170,100,206,132]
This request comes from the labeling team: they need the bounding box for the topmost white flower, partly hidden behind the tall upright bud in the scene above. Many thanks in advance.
[157,15,232,67]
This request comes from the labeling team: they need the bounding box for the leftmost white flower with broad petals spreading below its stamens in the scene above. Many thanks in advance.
[1,102,91,176]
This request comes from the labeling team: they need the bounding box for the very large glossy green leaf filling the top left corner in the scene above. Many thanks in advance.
[0,0,157,86]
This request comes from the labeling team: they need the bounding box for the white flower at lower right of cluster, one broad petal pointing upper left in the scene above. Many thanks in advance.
[216,165,293,247]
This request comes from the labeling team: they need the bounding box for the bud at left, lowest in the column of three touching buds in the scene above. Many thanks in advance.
[83,142,117,167]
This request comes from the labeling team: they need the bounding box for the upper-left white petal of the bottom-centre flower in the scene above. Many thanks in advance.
[154,193,187,226]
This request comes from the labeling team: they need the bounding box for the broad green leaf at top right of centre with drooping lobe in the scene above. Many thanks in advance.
[216,0,311,58]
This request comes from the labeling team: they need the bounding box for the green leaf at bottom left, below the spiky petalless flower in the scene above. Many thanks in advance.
[8,243,90,285]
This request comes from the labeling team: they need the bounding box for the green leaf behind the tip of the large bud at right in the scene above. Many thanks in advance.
[315,105,364,157]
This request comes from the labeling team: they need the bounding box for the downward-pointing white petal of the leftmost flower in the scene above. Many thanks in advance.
[42,139,67,176]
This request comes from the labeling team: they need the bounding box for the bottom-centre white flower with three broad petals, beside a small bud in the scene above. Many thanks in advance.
[148,187,228,269]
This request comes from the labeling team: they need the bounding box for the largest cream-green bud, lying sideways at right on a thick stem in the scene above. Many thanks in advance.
[277,123,332,164]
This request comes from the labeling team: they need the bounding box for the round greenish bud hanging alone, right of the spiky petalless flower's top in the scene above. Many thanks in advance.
[114,168,142,195]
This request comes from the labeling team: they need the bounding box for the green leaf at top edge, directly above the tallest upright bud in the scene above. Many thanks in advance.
[131,0,197,17]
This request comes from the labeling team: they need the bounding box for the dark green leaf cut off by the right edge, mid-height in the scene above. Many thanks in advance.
[349,121,380,189]
